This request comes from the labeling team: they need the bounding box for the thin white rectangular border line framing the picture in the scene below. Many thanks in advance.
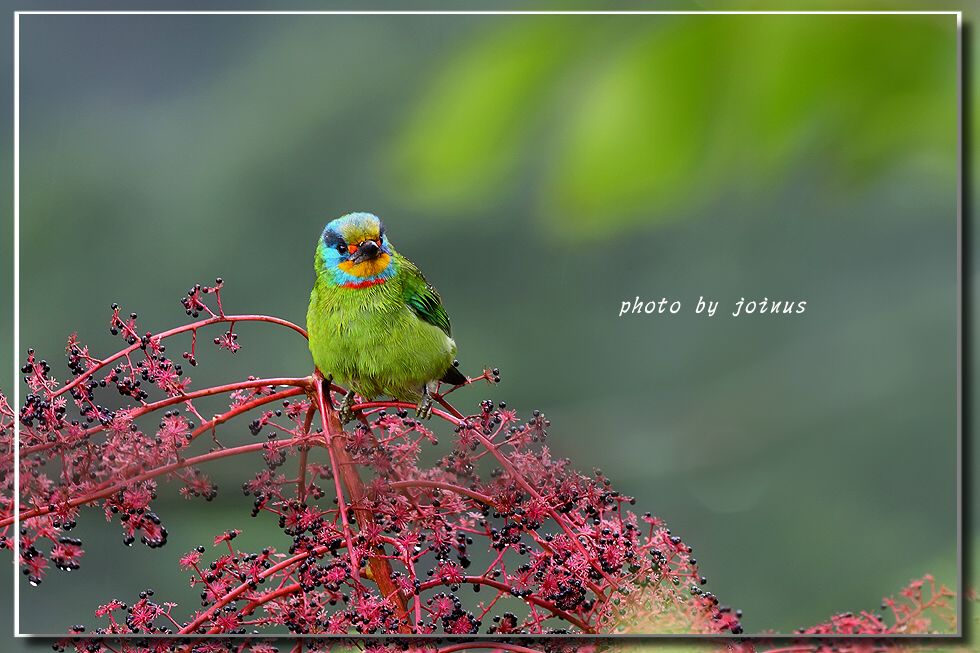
[11,10,964,640]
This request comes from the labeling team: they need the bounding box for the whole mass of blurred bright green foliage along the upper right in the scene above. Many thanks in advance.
[394,15,956,237]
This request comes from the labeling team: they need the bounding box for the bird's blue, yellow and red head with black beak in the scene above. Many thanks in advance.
[317,213,396,288]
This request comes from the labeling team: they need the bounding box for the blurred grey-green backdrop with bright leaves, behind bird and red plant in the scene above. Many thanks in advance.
[0,0,956,632]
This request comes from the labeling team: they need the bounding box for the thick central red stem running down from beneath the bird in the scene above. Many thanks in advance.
[316,383,411,633]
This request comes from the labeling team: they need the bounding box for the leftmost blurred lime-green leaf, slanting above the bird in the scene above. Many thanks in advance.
[392,17,582,210]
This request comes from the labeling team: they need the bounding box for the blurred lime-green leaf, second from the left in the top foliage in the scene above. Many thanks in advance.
[542,20,726,234]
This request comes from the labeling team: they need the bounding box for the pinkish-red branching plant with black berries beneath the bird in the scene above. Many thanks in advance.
[0,279,950,653]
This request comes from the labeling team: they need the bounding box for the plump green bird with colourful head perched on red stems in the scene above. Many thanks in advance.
[306,213,466,422]
